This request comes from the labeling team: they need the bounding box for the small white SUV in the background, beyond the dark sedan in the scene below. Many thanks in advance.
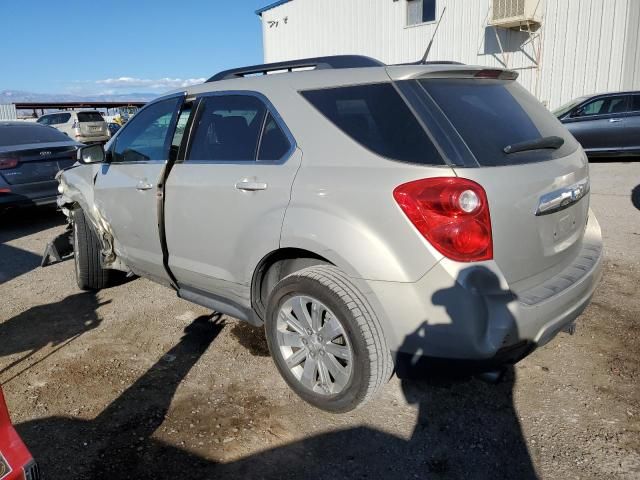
[36,110,111,144]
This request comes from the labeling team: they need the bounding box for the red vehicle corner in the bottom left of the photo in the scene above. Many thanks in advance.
[0,387,42,480]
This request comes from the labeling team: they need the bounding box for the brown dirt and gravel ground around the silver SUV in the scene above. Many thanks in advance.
[0,162,640,479]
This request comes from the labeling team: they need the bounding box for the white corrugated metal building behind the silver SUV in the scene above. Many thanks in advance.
[256,0,640,108]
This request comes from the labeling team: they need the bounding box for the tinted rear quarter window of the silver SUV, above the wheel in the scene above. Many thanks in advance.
[302,83,444,165]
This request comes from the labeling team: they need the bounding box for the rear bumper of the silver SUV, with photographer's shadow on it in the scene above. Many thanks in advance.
[365,210,603,369]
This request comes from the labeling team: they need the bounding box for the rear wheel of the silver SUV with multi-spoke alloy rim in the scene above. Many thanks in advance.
[265,265,393,413]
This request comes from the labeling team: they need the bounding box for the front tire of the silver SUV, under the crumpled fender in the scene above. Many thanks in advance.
[73,208,111,290]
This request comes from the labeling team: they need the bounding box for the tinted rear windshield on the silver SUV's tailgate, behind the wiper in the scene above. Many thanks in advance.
[419,79,578,166]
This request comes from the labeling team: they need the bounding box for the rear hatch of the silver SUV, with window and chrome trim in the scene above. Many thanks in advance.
[398,71,589,291]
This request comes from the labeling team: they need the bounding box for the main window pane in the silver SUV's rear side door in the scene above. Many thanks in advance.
[187,95,267,162]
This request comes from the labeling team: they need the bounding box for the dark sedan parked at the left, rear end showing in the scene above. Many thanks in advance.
[0,121,81,210]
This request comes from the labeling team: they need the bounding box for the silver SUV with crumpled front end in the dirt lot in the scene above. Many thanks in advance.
[48,56,602,412]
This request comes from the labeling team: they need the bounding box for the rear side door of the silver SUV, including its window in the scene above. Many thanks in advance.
[162,93,301,303]
